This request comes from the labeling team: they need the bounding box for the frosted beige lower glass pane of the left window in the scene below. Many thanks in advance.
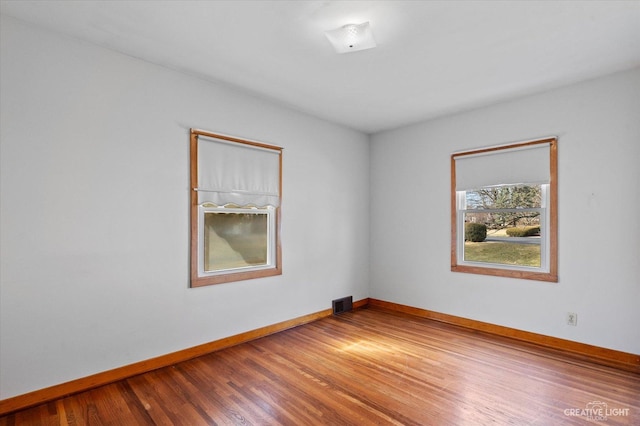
[204,212,268,272]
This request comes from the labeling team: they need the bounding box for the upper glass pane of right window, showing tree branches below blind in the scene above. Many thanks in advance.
[466,184,542,209]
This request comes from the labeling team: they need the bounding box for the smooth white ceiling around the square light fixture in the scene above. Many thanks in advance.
[0,0,640,133]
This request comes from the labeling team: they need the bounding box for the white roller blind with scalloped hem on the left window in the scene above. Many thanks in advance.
[198,136,280,207]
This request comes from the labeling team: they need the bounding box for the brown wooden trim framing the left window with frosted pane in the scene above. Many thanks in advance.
[190,129,283,287]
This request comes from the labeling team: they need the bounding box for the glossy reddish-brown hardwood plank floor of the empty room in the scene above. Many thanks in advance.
[0,308,640,426]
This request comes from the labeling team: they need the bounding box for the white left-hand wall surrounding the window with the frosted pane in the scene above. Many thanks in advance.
[0,17,369,399]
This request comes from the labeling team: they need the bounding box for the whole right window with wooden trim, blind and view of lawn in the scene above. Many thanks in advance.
[451,138,558,282]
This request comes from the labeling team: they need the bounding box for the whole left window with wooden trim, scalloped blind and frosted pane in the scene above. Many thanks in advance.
[191,130,282,287]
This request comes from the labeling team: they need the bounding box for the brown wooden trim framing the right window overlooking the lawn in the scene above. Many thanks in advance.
[451,137,558,282]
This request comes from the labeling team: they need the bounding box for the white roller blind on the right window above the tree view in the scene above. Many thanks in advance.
[453,143,550,191]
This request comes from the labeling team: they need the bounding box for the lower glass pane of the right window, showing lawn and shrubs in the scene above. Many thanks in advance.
[464,210,542,268]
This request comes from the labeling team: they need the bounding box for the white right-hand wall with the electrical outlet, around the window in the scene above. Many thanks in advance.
[370,69,640,354]
